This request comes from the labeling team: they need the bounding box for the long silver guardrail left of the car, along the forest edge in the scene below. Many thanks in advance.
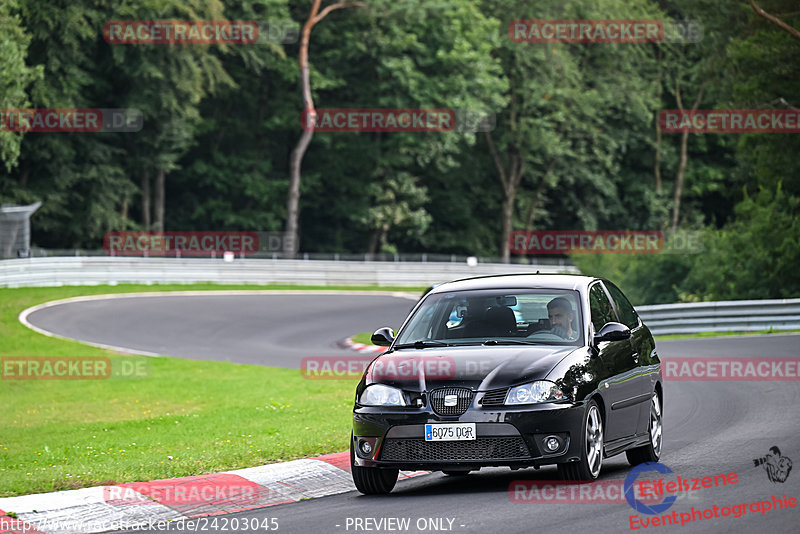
[0,257,578,287]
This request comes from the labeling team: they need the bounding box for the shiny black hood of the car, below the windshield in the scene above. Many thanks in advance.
[365,345,577,392]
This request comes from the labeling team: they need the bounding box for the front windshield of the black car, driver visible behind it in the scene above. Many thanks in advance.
[395,289,583,348]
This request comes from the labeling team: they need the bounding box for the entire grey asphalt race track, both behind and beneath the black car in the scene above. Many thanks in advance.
[28,295,800,534]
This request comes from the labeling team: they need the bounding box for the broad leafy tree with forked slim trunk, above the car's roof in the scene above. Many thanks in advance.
[485,1,657,260]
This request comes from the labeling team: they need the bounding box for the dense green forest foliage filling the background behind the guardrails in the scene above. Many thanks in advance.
[0,0,800,303]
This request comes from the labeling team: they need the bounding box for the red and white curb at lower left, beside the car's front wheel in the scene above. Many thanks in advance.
[0,452,428,534]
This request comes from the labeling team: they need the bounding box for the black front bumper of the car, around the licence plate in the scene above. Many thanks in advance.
[353,403,584,471]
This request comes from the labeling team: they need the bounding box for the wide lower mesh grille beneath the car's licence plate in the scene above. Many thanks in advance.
[380,436,530,462]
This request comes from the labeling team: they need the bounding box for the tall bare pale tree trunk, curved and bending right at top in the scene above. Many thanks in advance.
[283,0,364,256]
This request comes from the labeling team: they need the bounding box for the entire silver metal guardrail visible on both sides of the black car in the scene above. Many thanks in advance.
[0,256,800,335]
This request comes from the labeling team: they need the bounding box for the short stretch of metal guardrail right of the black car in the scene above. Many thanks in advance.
[636,299,800,335]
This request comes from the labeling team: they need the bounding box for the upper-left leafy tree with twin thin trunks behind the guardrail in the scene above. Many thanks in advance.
[109,0,233,232]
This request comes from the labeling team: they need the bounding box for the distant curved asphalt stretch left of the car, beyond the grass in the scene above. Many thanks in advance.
[23,294,418,368]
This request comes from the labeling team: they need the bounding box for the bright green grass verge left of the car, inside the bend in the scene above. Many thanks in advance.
[0,284,421,497]
